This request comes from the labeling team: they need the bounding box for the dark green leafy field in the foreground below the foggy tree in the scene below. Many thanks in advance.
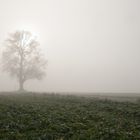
[0,93,140,140]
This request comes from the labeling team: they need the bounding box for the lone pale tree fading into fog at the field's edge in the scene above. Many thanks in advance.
[2,31,46,91]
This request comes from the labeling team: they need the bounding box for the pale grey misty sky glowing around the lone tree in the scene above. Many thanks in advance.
[0,0,140,92]
